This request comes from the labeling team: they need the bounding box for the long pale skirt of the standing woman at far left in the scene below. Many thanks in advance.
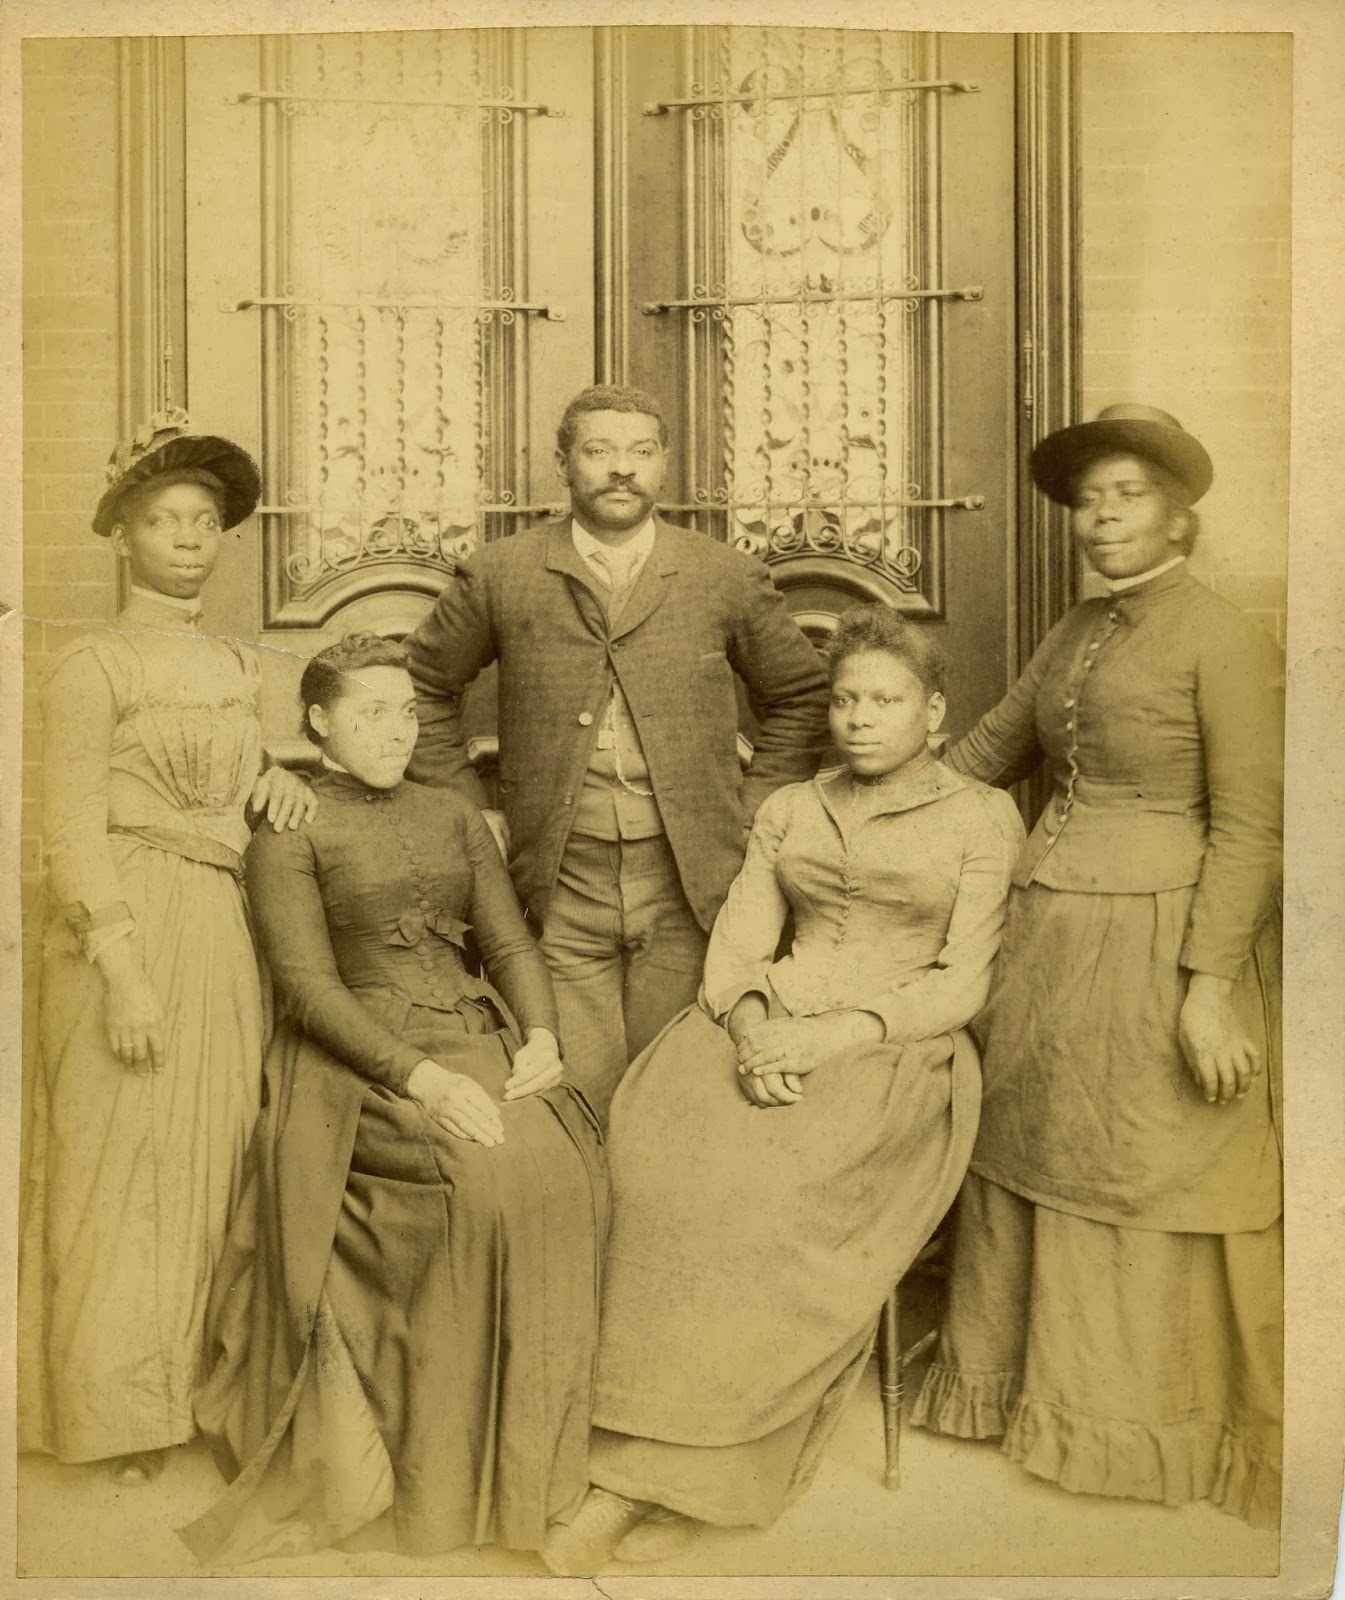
[19,837,262,1461]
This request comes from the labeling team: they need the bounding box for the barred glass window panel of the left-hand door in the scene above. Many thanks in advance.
[233,29,563,627]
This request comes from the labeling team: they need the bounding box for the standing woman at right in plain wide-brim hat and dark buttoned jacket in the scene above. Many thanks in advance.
[915,405,1283,1525]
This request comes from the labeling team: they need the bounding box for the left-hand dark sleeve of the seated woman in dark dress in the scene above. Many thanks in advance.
[245,827,424,1094]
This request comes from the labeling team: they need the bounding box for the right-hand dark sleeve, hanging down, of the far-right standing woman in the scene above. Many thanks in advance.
[1182,613,1284,978]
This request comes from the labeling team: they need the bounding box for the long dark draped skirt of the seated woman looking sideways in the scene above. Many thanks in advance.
[182,1000,606,1563]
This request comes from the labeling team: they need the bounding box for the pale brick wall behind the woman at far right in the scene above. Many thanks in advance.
[1081,34,1292,643]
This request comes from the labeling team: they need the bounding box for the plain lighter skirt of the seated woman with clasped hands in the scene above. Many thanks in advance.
[590,1008,979,1523]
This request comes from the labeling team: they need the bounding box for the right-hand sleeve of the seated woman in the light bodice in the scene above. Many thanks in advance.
[864,790,1024,1043]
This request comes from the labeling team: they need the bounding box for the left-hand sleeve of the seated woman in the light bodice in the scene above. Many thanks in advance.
[704,784,803,1021]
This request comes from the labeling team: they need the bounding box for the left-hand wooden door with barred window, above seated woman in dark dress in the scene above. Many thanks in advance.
[186,29,593,742]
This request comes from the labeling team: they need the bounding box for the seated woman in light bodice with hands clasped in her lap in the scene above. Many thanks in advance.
[544,606,1024,1573]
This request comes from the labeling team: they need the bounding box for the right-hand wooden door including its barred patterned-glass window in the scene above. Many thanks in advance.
[619,27,1016,726]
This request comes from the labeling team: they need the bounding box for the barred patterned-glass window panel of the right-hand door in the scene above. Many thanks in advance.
[645,27,984,614]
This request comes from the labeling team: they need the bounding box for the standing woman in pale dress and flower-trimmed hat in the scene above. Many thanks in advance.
[19,410,313,1485]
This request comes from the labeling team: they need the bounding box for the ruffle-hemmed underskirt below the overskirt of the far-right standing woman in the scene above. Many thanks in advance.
[913,1173,1283,1526]
